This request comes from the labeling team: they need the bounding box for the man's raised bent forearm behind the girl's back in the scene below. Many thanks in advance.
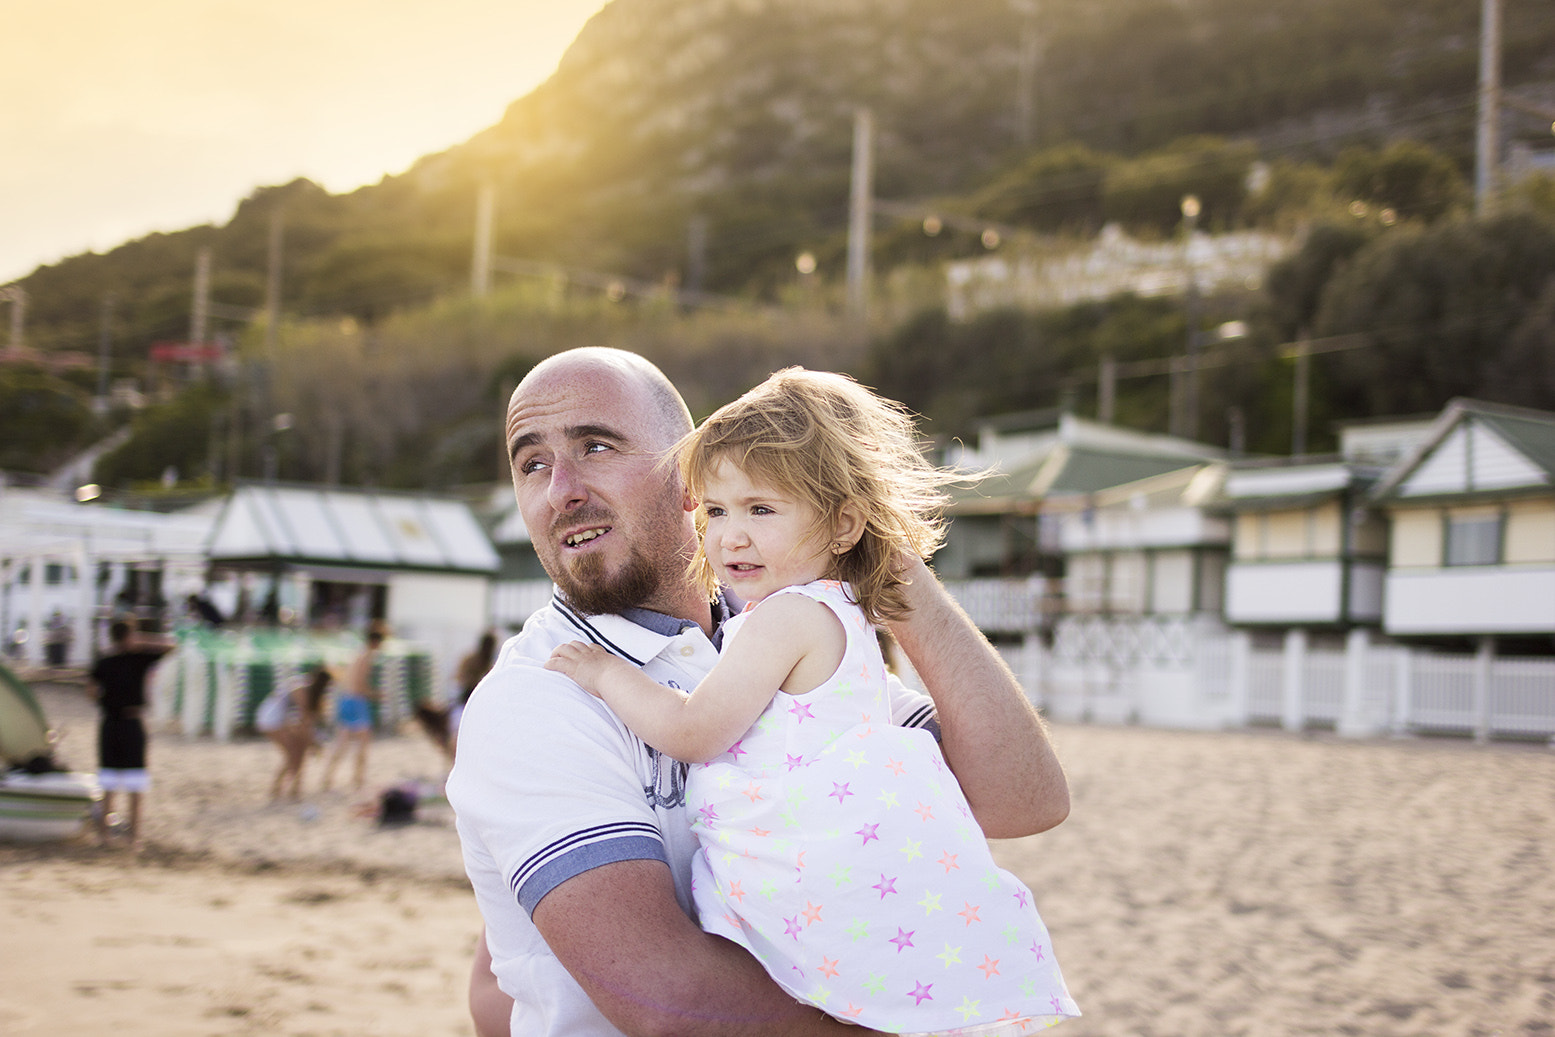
[891,558,1070,840]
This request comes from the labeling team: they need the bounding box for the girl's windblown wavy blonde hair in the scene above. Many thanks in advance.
[676,367,966,622]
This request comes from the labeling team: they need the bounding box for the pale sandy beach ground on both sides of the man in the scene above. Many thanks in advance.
[0,684,1555,1037]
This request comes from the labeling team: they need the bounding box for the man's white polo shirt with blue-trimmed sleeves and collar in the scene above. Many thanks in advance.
[448,597,936,1037]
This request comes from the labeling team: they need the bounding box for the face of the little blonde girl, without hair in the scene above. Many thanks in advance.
[701,459,832,605]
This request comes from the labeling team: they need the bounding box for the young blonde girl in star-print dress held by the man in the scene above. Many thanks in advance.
[546,368,1079,1034]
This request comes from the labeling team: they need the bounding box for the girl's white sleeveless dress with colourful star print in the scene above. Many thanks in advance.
[686,580,1079,1034]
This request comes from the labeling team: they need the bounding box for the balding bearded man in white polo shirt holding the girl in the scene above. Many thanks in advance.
[448,348,1068,1037]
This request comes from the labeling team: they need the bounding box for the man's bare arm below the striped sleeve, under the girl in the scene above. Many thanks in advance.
[533,860,874,1037]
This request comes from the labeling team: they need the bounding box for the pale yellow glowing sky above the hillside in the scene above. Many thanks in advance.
[0,0,605,285]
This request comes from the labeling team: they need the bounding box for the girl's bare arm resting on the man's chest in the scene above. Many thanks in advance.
[546,594,846,763]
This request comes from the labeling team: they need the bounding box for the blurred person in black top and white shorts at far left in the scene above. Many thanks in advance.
[90,619,173,849]
